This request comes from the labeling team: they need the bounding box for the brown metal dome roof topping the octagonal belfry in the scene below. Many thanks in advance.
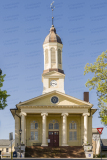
[43,25,62,44]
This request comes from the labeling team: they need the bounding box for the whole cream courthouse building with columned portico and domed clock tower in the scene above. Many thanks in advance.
[11,25,96,147]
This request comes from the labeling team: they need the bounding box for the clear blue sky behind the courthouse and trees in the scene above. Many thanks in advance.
[0,0,107,139]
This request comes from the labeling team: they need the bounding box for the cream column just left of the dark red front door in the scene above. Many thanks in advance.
[41,113,48,146]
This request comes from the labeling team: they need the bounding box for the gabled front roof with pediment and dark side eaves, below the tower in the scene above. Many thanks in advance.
[10,90,96,118]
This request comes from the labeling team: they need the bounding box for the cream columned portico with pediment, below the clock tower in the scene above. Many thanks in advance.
[11,91,95,146]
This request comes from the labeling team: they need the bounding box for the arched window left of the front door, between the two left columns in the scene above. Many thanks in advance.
[31,121,38,140]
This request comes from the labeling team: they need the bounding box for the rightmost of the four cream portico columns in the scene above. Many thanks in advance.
[83,113,90,144]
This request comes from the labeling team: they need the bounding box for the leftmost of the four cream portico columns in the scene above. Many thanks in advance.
[20,112,26,144]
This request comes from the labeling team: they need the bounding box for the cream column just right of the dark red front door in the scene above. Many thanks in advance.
[62,113,68,146]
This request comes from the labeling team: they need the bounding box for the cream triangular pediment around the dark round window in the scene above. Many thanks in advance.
[17,91,93,108]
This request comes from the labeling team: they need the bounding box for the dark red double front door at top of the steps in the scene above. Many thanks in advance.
[48,131,59,147]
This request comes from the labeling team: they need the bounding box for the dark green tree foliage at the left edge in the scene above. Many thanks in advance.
[0,69,10,110]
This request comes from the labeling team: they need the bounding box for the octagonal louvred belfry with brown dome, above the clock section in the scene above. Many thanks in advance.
[43,25,63,71]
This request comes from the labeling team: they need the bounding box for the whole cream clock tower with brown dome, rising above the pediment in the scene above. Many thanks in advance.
[42,25,65,94]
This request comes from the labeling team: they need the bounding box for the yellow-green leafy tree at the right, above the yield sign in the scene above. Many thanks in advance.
[84,50,107,126]
